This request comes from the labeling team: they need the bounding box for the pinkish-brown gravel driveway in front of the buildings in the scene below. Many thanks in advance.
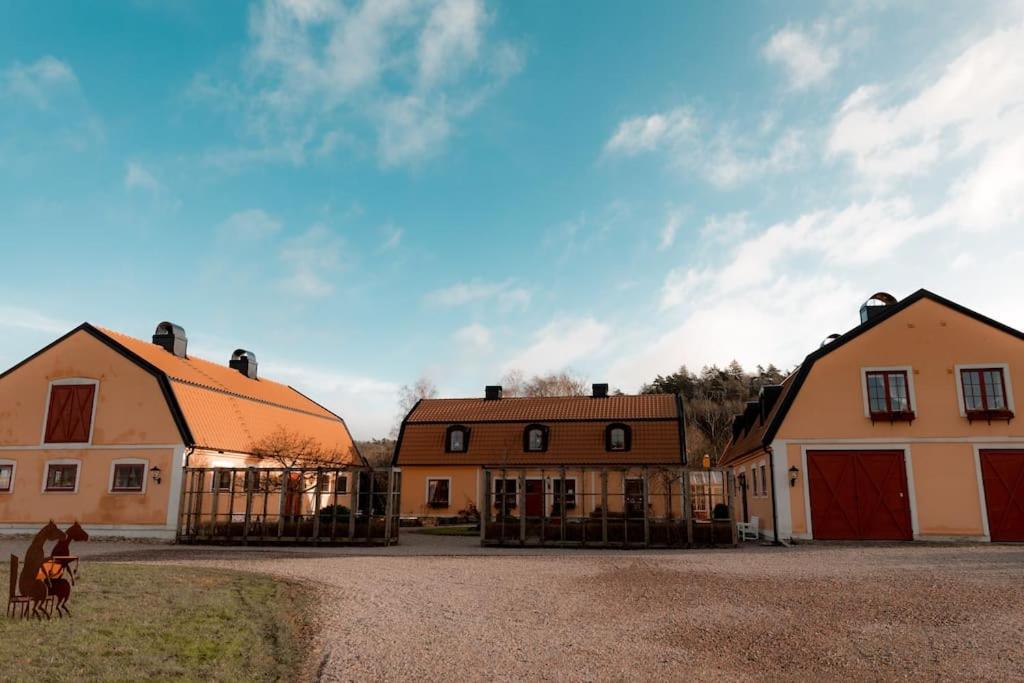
[0,533,1024,680]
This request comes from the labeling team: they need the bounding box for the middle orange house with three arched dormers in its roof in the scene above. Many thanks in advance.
[394,384,686,518]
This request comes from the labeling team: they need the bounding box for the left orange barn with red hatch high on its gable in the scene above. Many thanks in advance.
[0,323,361,539]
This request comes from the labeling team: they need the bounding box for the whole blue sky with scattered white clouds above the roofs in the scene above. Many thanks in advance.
[0,0,1024,437]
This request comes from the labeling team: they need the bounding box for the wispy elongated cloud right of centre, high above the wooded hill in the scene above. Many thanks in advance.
[604,108,805,188]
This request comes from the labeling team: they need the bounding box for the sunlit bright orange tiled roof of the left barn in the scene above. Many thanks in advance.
[90,324,359,461]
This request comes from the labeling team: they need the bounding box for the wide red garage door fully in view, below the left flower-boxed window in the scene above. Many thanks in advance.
[807,451,913,541]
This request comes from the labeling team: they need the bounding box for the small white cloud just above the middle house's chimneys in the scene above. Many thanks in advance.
[502,317,611,375]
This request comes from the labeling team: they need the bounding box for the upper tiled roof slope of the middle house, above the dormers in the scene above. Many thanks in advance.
[407,394,678,423]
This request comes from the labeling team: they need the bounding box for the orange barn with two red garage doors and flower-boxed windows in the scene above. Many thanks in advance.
[722,290,1024,541]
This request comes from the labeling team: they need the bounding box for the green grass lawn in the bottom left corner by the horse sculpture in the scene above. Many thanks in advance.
[0,562,311,681]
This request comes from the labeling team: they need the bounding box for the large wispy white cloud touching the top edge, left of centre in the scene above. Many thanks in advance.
[189,0,523,167]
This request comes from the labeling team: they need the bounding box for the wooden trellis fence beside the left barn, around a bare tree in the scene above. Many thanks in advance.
[177,466,401,546]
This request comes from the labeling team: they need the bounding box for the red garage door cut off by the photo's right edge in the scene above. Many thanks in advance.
[981,451,1024,541]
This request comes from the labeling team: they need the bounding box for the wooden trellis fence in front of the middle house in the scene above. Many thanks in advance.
[480,466,736,548]
